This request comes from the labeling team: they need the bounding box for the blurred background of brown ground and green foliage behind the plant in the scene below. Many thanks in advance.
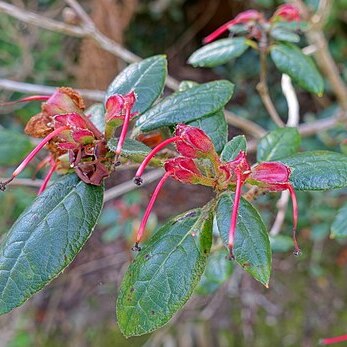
[0,0,347,347]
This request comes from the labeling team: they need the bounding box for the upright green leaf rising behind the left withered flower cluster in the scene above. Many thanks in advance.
[105,55,167,114]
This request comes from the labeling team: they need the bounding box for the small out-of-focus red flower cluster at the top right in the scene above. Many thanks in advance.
[203,4,300,43]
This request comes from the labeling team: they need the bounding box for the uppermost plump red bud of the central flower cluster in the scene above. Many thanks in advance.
[175,124,217,158]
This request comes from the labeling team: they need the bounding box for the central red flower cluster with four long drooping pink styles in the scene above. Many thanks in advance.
[133,124,300,257]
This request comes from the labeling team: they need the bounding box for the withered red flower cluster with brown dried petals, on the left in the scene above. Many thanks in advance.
[0,87,136,194]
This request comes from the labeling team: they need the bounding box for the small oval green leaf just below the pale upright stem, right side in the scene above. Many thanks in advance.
[257,128,301,161]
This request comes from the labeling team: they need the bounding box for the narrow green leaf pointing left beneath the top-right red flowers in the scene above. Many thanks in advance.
[188,37,249,67]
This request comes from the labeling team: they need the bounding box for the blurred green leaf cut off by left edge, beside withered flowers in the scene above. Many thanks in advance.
[0,128,33,166]
